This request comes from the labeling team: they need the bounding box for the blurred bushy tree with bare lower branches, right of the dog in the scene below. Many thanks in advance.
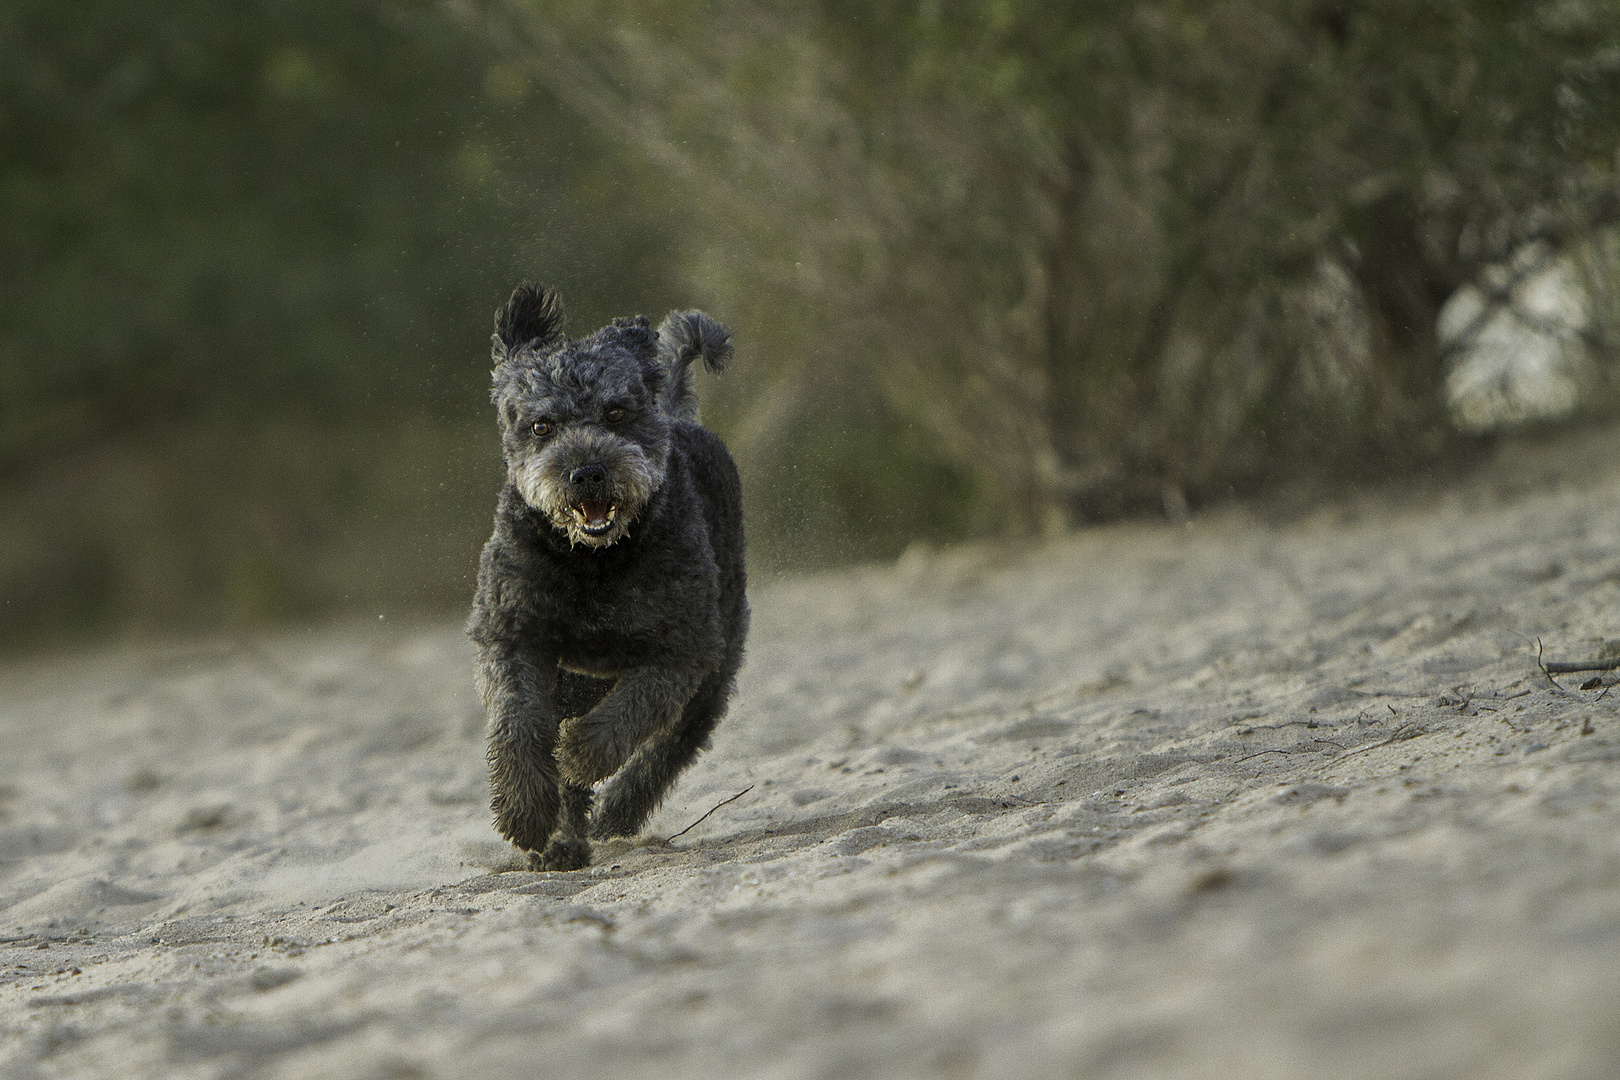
[473,0,1620,529]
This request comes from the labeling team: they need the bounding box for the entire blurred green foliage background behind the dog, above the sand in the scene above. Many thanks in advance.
[0,0,1620,643]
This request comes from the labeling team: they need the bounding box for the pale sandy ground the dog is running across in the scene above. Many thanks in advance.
[0,431,1620,1080]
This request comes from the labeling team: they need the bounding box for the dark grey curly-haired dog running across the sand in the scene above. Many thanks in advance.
[467,283,748,870]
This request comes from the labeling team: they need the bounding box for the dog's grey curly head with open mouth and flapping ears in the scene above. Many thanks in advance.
[492,283,671,547]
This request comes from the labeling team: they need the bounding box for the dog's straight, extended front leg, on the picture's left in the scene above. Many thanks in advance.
[478,644,562,853]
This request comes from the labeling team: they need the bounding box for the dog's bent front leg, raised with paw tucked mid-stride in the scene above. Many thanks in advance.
[557,667,706,784]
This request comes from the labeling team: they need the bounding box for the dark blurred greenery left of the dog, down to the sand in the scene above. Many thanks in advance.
[0,0,679,638]
